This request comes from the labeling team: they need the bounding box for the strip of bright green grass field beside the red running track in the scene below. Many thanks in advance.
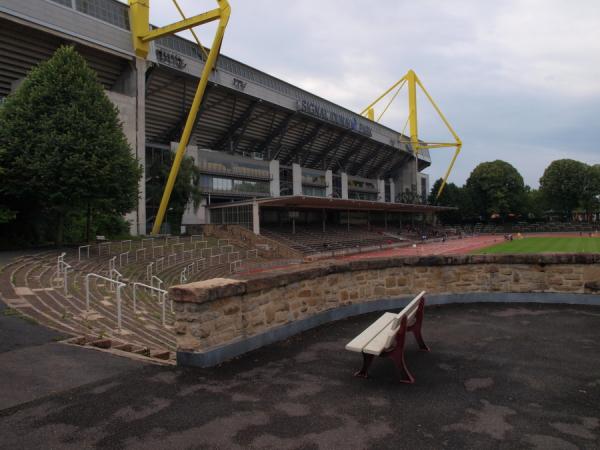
[473,237,600,254]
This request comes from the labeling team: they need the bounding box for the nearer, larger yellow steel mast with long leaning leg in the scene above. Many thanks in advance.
[129,0,231,235]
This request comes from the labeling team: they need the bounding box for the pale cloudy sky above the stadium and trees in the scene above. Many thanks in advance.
[144,0,600,187]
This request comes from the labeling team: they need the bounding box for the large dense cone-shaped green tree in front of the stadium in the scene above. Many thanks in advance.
[0,46,141,244]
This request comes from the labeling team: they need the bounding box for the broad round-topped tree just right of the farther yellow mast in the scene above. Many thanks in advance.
[466,160,525,219]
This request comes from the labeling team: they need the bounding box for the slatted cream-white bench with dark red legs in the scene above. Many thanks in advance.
[346,291,429,384]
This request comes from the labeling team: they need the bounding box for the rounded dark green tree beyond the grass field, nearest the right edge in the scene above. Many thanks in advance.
[540,159,590,217]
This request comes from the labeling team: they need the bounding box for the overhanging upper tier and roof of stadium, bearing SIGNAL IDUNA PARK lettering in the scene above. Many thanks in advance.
[0,0,430,178]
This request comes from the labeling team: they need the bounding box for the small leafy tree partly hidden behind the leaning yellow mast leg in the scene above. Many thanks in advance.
[146,152,202,233]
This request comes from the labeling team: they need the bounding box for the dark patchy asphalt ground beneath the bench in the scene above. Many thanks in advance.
[0,304,600,450]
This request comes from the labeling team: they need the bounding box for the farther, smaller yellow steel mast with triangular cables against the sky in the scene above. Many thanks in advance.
[361,70,462,198]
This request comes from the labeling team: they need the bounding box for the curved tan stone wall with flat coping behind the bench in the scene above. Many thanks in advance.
[169,254,600,365]
